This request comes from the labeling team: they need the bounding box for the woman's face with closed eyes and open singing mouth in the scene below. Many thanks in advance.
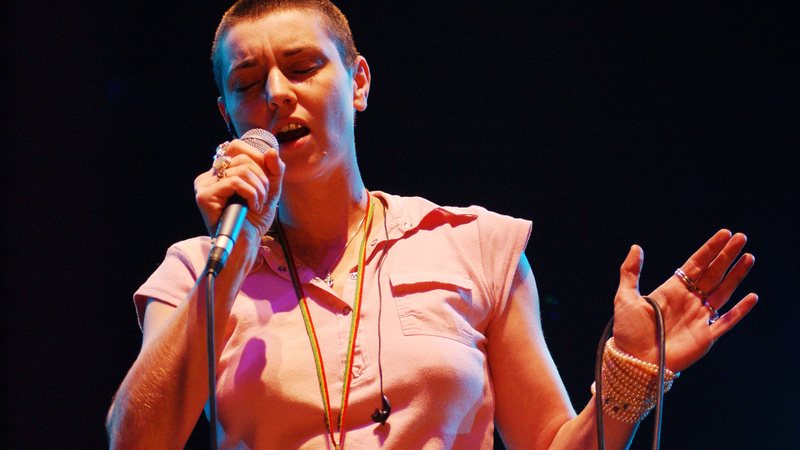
[218,10,370,183]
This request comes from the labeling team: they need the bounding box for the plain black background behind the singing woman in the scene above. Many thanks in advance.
[0,0,800,449]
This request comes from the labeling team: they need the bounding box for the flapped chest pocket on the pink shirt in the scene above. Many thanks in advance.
[389,272,477,346]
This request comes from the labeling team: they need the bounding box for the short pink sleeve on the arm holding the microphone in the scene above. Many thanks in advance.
[133,237,211,327]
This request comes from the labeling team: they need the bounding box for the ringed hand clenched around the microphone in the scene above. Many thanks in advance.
[194,139,285,241]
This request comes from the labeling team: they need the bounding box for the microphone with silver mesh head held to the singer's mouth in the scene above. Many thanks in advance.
[206,128,278,277]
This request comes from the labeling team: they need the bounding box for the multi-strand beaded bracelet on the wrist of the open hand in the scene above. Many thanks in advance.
[591,337,680,423]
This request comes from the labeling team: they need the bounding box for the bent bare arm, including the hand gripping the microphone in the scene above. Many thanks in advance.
[106,140,283,448]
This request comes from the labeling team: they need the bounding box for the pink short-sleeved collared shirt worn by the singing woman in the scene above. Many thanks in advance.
[134,192,531,449]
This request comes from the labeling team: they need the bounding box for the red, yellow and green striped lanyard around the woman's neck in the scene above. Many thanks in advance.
[275,196,374,450]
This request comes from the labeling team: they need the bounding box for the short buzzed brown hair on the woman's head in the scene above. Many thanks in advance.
[211,0,358,95]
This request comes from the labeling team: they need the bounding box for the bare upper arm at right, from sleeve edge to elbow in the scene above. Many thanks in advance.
[488,254,575,448]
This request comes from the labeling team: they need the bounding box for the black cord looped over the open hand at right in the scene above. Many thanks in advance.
[594,296,667,450]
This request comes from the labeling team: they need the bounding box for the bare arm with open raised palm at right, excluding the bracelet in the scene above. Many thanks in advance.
[489,230,757,449]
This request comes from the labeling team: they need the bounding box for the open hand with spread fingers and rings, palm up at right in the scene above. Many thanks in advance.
[614,230,758,372]
